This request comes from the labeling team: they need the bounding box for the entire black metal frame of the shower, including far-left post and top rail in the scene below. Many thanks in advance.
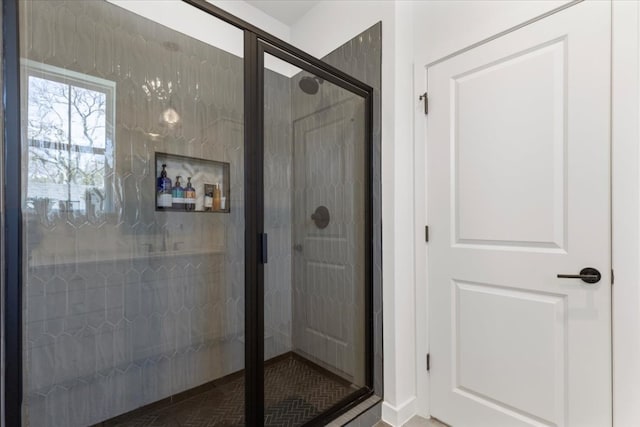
[1,0,373,427]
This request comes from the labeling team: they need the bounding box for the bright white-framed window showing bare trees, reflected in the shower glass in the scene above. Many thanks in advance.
[24,61,115,214]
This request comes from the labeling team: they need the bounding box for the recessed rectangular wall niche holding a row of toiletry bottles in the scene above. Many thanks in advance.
[155,152,231,213]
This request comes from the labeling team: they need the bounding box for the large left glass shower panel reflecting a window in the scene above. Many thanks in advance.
[20,0,245,427]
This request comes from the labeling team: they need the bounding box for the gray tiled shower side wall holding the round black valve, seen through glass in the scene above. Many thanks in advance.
[291,76,365,385]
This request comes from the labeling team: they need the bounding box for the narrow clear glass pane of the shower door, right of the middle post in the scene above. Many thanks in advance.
[264,54,367,426]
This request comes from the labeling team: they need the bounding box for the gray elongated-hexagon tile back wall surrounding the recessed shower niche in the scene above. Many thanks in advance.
[21,1,291,426]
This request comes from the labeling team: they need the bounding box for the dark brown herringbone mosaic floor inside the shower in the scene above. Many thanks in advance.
[102,354,355,427]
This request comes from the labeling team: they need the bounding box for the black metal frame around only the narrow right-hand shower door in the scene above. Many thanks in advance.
[250,39,373,426]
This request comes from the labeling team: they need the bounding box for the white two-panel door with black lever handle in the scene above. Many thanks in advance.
[426,1,612,427]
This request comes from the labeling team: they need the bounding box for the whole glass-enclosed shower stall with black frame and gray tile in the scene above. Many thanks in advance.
[3,0,381,427]
